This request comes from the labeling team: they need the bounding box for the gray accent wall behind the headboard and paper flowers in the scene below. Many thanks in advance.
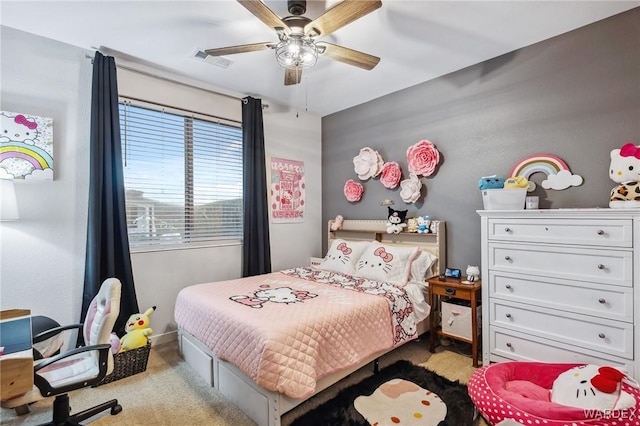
[322,8,640,269]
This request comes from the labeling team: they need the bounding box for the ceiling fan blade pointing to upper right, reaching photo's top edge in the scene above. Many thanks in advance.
[304,0,382,37]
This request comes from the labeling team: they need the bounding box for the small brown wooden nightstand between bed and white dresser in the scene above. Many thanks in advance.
[427,277,482,367]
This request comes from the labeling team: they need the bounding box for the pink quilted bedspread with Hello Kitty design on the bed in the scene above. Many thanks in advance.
[175,268,417,398]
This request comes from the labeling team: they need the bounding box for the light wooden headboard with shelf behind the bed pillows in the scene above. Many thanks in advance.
[327,219,447,274]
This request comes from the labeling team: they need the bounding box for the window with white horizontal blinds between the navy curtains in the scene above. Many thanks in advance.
[120,101,243,248]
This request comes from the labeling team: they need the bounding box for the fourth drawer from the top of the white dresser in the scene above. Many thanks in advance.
[489,299,633,359]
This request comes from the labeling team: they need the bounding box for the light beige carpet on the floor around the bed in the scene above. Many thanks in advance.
[0,339,485,426]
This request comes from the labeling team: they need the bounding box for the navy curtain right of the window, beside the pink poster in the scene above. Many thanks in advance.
[242,96,271,277]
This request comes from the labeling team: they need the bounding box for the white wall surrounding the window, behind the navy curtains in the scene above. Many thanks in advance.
[0,27,324,339]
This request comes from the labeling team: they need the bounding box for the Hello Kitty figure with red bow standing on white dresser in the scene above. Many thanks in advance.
[609,143,640,209]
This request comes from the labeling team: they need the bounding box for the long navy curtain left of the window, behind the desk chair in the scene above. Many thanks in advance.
[80,52,140,336]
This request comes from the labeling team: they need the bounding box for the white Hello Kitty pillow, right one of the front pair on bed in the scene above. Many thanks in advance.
[356,241,419,285]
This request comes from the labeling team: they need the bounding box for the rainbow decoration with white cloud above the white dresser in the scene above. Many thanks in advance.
[510,154,582,192]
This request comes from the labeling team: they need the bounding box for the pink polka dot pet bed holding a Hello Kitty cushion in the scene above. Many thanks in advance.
[467,361,640,426]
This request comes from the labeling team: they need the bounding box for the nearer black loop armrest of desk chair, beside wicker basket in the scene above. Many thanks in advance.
[33,343,111,396]
